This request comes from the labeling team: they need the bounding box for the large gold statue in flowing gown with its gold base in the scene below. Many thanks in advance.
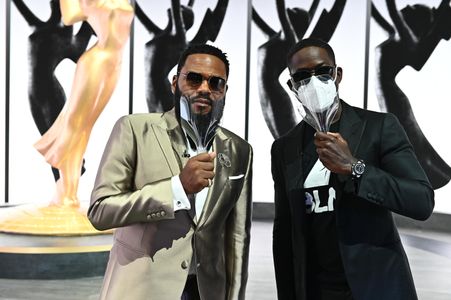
[0,0,134,235]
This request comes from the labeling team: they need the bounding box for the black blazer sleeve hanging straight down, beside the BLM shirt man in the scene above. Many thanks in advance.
[271,141,296,300]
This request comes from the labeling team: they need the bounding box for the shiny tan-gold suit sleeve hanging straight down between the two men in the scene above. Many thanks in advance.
[226,145,253,300]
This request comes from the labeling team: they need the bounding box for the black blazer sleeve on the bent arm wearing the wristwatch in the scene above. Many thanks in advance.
[357,114,434,220]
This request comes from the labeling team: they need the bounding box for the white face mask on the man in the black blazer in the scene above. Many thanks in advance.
[292,75,340,132]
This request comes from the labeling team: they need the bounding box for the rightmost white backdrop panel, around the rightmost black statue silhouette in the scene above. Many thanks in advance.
[368,0,451,213]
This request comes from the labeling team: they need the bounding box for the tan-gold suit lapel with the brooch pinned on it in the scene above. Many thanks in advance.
[198,128,231,225]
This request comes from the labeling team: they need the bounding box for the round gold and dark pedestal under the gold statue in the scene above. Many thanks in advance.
[0,205,113,279]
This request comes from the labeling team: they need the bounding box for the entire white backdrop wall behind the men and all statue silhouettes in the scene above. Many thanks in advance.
[0,0,451,213]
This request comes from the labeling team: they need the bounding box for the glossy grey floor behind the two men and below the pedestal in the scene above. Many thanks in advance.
[0,221,451,300]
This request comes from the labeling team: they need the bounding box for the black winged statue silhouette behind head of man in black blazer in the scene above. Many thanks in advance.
[252,0,346,138]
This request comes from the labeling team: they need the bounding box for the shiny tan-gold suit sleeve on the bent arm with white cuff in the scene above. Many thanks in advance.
[88,117,174,230]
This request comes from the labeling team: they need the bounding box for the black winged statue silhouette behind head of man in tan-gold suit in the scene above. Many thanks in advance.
[135,0,229,112]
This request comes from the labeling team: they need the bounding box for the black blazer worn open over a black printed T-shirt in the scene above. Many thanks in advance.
[271,101,434,300]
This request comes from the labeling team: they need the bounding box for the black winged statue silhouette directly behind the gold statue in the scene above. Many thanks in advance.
[12,0,93,181]
